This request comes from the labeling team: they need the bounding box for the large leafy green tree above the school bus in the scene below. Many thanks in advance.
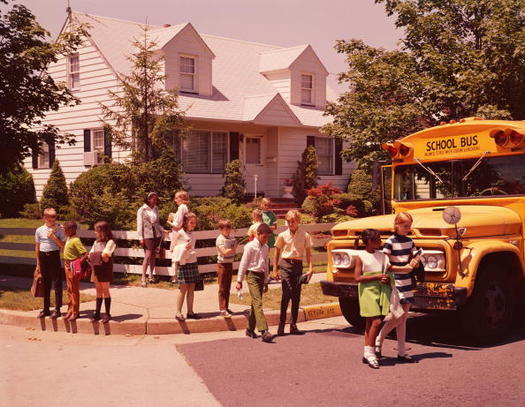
[323,0,525,171]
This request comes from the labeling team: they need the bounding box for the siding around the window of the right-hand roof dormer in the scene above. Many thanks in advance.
[290,47,327,108]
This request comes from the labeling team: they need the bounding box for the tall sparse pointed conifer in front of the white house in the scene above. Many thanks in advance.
[102,26,186,162]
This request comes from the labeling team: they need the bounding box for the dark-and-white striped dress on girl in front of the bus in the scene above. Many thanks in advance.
[383,233,417,304]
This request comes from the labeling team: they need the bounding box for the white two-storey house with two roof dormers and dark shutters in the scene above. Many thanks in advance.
[25,12,351,197]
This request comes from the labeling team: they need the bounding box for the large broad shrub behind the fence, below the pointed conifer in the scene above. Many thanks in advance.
[70,154,182,229]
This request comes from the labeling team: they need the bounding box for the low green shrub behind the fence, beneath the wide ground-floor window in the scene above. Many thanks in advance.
[190,197,251,230]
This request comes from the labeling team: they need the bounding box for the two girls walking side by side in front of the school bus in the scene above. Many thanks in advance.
[354,212,420,369]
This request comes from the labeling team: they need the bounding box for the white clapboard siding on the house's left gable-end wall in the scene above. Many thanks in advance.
[24,42,124,198]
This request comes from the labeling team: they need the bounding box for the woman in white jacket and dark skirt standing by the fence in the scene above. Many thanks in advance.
[137,192,164,287]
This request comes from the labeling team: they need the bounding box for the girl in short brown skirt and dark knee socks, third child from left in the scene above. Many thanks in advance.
[88,222,116,323]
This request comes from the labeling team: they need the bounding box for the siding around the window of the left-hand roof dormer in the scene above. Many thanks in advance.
[164,26,213,96]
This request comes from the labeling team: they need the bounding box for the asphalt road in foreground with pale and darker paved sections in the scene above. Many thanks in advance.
[0,317,525,407]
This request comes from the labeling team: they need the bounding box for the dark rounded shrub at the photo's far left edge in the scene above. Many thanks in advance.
[0,165,38,218]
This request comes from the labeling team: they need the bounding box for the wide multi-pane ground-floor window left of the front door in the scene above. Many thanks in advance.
[181,130,228,174]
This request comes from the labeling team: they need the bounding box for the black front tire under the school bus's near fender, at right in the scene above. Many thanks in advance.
[460,267,515,344]
